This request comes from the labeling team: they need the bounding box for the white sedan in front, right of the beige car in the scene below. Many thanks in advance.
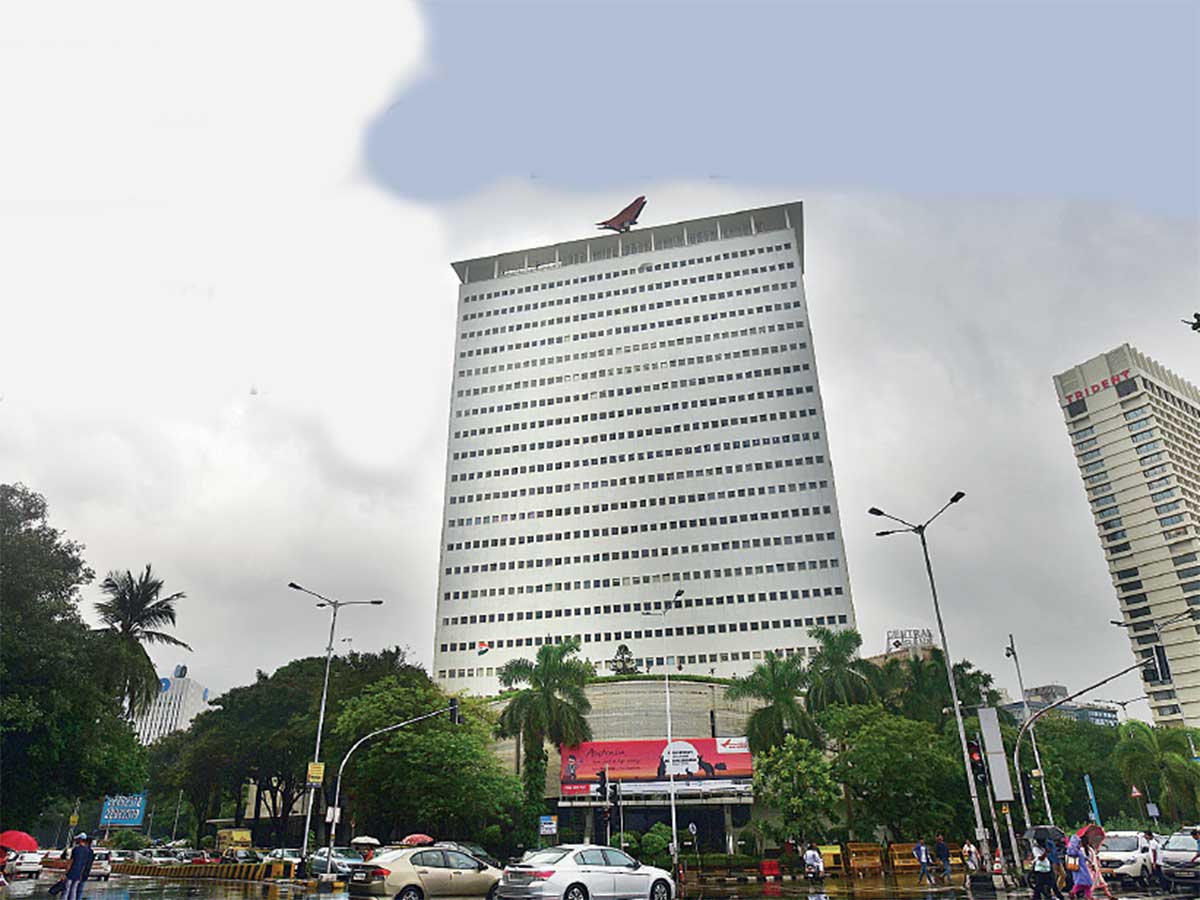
[497,844,676,900]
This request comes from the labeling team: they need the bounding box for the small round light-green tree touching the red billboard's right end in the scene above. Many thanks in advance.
[754,734,838,840]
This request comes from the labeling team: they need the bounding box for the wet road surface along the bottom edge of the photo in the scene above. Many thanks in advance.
[0,872,1184,900]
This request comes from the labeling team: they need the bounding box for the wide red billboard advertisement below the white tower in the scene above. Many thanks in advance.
[560,738,754,799]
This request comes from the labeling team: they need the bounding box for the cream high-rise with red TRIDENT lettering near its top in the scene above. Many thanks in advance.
[1054,344,1200,727]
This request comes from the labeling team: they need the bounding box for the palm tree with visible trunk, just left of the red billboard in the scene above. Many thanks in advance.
[497,637,595,809]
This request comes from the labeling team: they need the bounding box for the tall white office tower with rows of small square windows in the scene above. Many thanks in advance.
[433,203,854,694]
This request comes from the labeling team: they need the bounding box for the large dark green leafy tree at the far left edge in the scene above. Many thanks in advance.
[0,485,145,829]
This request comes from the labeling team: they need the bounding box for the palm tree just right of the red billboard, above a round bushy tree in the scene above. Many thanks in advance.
[725,650,818,754]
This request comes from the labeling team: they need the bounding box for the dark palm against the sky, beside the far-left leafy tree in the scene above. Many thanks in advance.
[96,565,192,719]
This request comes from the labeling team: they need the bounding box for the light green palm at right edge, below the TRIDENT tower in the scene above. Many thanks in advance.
[1112,720,1200,821]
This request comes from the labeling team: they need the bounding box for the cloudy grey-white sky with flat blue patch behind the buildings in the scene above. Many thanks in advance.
[0,0,1200,720]
